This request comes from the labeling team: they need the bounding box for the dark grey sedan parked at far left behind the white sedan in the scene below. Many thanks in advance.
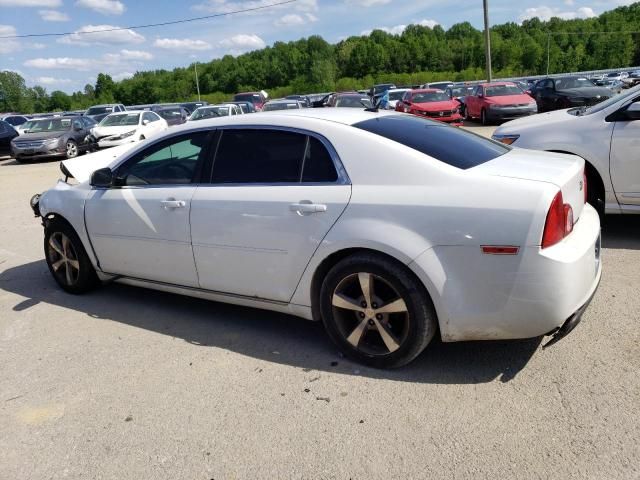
[11,117,95,162]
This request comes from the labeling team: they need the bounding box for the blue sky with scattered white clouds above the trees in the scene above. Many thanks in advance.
[0,0,633,93]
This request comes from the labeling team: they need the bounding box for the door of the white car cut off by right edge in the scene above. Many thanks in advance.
[610,106,640,205]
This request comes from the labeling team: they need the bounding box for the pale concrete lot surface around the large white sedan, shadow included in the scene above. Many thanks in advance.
[0,124,640,480]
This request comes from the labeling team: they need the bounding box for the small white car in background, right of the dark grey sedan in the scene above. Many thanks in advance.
[91,110,169,148]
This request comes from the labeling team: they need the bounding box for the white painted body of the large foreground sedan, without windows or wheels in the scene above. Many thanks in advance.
[39,109,601,354]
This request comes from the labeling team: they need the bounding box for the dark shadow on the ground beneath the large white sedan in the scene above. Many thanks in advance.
[0,260,540,384]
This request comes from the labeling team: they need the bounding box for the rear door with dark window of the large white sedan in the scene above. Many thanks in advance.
[191,128,351,302]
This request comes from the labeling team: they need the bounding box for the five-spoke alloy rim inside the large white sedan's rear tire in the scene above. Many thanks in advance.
[331,272,410,356]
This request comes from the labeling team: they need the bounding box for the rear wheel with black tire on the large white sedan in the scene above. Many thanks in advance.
[319,252,438,368]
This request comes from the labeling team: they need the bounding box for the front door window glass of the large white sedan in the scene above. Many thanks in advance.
[116,132,209,186]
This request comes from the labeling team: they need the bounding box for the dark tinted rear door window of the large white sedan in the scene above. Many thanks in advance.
[212,129,338,184]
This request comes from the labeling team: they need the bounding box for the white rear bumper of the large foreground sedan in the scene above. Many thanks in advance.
[409,205,602,342]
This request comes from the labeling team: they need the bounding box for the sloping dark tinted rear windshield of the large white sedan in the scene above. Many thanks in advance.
[353,115,511,170]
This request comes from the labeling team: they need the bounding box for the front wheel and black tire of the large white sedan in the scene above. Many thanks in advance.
[44,220,99,294]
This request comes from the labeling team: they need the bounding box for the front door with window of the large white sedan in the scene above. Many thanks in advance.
[85,132,209,287]
